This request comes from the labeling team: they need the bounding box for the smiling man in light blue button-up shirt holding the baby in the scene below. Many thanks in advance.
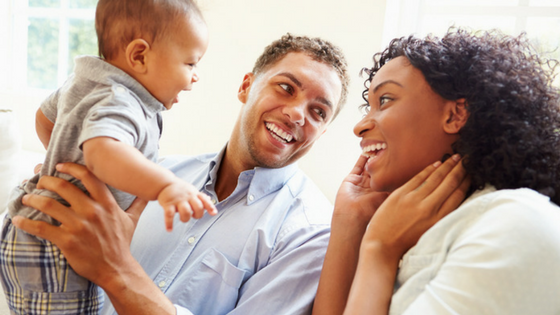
[14,34,348,315]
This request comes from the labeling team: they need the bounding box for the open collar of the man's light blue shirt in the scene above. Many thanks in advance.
[205,144,299,205]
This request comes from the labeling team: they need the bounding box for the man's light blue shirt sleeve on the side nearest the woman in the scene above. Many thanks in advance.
[229,222,330,315]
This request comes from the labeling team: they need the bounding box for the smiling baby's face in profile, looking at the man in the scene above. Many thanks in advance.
[142,17,208,109]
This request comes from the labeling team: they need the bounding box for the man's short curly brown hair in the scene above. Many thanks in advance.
[252,33,350,119]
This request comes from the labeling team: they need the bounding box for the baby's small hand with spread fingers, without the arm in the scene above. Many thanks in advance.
[158,180,218,232]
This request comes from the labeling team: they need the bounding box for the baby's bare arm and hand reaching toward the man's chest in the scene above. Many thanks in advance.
[83,137,217,230]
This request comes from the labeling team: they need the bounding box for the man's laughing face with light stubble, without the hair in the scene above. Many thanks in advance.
[231,53,342,169]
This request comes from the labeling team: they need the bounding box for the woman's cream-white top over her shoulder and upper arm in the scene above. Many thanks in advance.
[404,195,560,314]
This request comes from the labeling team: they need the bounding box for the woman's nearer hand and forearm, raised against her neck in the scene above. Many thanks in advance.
[344,155,470,315]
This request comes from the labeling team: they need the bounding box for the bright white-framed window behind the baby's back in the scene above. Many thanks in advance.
[4,0,97,90]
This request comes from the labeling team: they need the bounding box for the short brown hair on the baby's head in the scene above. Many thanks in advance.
[95,0,202,60]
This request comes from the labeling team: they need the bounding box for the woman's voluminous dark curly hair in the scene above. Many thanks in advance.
[365,28,560,204]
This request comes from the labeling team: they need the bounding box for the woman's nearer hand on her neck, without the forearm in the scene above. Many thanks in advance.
[362,154,470,260]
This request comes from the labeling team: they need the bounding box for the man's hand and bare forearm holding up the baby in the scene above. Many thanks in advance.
[13,163,176,315]
